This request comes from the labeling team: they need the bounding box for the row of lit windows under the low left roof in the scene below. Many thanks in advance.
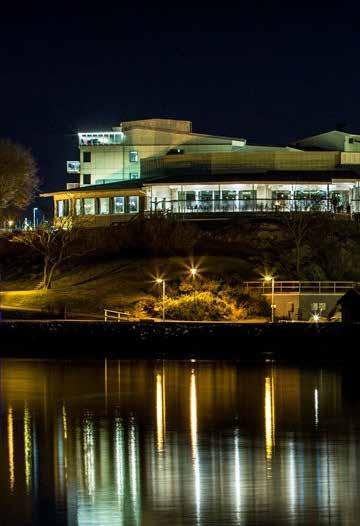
[56,195,139,217]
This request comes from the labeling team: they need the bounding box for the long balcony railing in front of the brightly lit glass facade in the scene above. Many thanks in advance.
[150,199,351,214]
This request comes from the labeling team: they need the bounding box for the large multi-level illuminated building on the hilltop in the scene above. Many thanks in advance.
[43,119,360,226]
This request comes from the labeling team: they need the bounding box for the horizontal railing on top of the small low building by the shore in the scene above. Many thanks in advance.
[243,280,360,294]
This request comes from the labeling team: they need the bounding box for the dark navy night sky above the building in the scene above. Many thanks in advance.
[0,2,360,202]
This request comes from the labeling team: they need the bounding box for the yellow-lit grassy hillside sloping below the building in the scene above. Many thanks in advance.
[1,256,253,316]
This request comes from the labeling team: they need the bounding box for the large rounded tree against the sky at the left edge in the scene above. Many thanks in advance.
[0,140,39,215]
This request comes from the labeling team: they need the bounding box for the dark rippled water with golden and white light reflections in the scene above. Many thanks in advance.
[0,360,360,526]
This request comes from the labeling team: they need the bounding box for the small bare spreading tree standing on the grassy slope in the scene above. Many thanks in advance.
[11,218,91,289]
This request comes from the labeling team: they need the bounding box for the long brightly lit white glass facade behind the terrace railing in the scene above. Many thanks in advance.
[149,182,360,214]
